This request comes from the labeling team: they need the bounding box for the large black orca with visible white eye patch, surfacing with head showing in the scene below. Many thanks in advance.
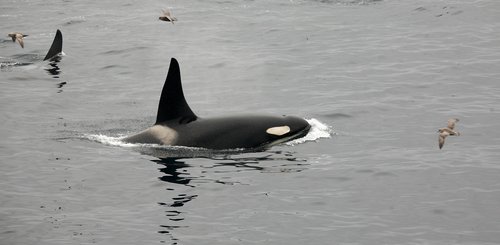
[122,58,311,150]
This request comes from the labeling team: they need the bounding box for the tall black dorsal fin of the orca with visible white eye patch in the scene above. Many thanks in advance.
[155,58,197,124]
